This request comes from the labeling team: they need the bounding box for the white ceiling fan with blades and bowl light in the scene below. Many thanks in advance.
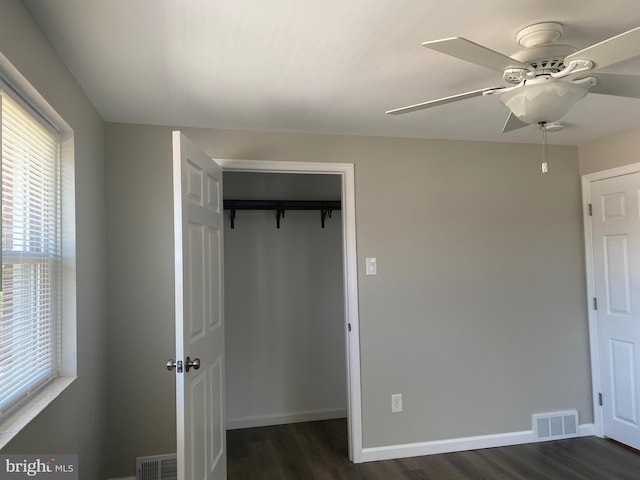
[386,22,640,133]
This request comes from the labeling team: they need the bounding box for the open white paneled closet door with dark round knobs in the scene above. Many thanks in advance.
[173,132,227,480]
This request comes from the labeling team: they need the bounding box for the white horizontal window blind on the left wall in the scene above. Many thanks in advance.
[0,92,61,417]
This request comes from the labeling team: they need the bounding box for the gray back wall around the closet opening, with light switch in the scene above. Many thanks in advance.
[106,124,593,470]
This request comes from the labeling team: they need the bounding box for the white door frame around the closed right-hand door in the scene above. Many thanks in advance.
[582,163,640,437]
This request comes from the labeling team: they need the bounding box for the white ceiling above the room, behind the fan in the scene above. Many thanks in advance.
[25,0,640,145]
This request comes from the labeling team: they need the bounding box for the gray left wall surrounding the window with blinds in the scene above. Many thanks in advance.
[0,0,106,479]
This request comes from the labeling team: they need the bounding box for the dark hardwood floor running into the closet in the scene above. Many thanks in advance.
[227,419,640,480]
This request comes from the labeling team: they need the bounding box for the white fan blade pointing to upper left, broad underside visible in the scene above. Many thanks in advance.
[422,37,531,72]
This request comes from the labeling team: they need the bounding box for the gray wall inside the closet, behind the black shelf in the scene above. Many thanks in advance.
[223,172,347,427]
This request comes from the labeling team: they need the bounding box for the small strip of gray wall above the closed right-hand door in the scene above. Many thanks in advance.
[579,125,640,175]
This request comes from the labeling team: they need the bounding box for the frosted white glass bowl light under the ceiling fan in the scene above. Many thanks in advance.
[500,81,588,124]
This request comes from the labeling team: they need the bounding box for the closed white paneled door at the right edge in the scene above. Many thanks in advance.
[591,173,640,449]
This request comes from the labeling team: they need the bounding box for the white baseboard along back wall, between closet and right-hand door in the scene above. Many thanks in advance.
[360,423,595,462]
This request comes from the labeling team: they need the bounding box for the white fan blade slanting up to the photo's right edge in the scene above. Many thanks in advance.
[564,27,640,69]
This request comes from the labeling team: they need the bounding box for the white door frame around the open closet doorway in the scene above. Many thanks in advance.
[214,158,362,463]
